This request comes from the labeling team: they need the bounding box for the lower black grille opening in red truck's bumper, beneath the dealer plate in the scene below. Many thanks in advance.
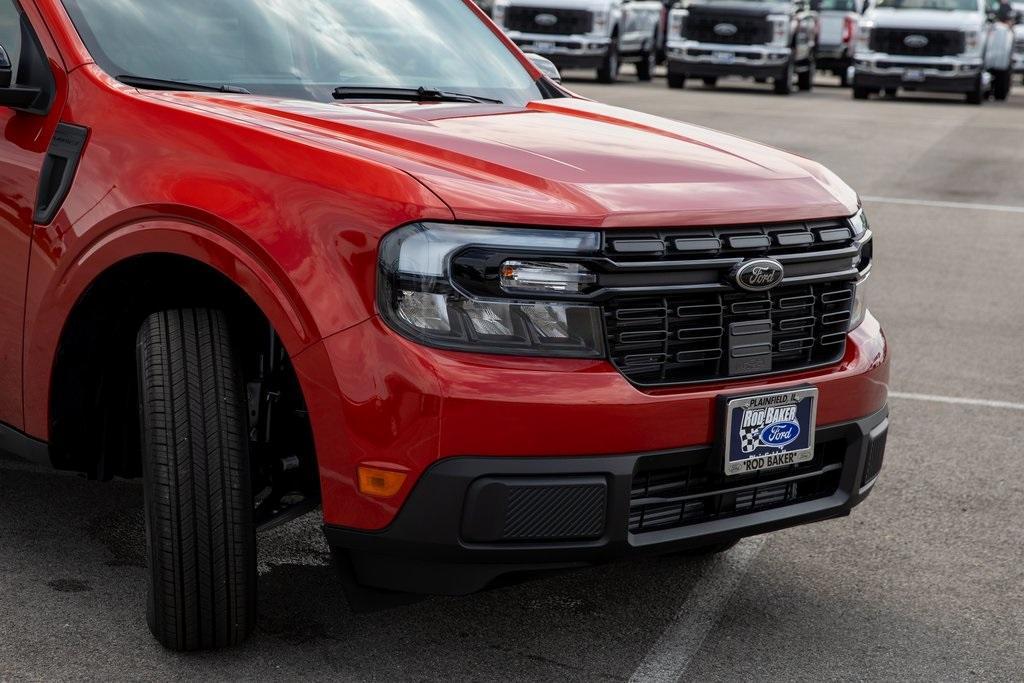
[630,436,847,533]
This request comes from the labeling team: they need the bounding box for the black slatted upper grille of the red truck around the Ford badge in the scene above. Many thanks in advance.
[604,221,870,386]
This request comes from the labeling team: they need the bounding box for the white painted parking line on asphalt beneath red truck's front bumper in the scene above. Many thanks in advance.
[630,536,765,683]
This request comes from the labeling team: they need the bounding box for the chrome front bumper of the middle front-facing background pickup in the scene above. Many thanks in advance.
[668,41,793,78]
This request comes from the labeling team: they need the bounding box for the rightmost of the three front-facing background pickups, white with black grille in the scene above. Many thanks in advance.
[853,0,1014,104]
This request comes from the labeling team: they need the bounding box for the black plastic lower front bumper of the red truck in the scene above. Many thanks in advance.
[326,409,889,595]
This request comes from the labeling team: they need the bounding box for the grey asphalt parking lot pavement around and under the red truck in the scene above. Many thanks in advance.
[0,68,1024,681]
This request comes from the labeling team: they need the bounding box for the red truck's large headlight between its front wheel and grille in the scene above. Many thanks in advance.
[378,223,604,358]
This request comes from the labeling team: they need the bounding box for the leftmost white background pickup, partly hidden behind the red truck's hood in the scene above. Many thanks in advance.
[490,0,665,83]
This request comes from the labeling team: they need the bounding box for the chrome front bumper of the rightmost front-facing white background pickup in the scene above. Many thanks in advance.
[854,53,987,92]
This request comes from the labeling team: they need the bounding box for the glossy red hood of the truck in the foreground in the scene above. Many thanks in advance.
[161,93,857,227]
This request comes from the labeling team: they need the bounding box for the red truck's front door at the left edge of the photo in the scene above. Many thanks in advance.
[0,0,61,429]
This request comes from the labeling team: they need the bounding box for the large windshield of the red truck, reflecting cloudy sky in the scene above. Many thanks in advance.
[63,0,541,104]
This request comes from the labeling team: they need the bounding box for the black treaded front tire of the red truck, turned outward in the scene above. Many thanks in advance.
[136,309,256,650]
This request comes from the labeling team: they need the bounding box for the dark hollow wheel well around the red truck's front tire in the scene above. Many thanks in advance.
[50,255,318,505]
